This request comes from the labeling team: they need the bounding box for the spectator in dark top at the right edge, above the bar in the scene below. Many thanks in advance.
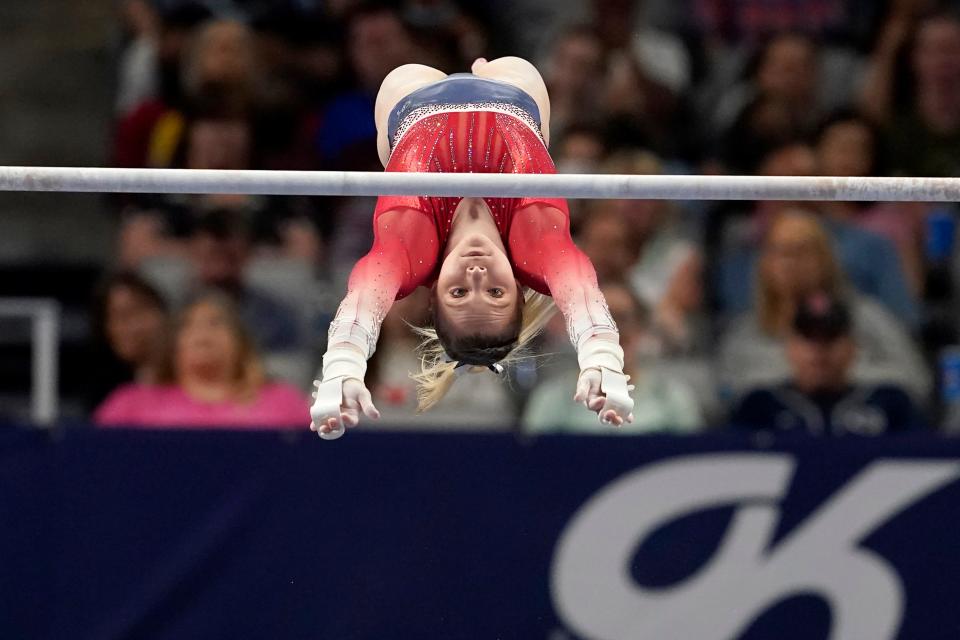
[861,8,960,177]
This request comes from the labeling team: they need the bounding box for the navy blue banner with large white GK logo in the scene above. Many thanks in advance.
[0,428,960,640]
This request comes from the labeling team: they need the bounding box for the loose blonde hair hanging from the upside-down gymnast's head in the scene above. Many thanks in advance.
[410,289,556,413]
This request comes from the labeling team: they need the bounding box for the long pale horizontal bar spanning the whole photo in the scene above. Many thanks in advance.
[0,167,960,202]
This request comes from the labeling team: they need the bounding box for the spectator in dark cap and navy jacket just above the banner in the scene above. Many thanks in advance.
[731,294,926,435]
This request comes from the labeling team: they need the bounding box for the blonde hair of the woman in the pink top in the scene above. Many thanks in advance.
[158,291,267,402]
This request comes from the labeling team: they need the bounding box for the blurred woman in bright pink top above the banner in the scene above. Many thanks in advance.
[94,294,309,428]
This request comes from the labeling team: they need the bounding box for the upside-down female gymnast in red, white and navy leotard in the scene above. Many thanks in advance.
[310,57,633,439]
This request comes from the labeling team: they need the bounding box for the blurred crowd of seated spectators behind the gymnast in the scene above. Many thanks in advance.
[75,0,960,434]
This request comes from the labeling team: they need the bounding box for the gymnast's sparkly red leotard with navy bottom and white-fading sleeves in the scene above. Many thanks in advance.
[328,74,617,357]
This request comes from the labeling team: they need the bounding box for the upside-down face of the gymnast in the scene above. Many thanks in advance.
[436,234,520,335]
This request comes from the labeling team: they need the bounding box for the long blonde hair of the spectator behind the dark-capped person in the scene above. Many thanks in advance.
[755,209,843,335]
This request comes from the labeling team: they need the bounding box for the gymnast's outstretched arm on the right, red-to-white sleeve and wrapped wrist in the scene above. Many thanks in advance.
[510,205,633,426]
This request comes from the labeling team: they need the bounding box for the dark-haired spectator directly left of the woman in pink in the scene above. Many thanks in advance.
[86,272,167,410]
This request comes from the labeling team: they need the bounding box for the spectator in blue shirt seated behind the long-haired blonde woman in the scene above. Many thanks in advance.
[716,144,920,329]
